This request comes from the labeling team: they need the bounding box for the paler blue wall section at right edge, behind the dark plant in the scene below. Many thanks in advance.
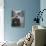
[40,0,46,27]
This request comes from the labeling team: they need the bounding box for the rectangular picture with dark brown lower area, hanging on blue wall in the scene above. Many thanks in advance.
[11,9,25,27]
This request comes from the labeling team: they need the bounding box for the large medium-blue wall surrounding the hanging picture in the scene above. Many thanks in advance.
[4,0,40,41]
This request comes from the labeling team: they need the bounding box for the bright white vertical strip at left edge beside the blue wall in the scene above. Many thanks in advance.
[0,0,4,42]
